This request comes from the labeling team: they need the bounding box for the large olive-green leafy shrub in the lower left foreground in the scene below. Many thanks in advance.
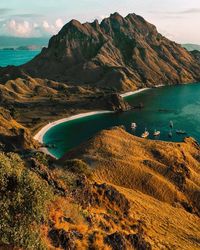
[0,153,53,249]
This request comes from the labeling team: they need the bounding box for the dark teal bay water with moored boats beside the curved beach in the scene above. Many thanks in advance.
[44,83,200,157]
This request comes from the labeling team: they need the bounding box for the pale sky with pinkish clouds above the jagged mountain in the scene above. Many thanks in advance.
[0,0,200,44]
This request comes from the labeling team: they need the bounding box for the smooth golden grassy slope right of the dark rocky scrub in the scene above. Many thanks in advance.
[65,128,200,250]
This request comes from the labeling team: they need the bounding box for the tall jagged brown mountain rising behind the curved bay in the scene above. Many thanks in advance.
[23,13,200,91]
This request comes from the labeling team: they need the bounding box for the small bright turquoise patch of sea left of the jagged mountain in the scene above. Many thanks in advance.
[0,50,40,67]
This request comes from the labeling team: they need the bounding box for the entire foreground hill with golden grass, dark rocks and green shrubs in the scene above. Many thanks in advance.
[0,128,200,250]
